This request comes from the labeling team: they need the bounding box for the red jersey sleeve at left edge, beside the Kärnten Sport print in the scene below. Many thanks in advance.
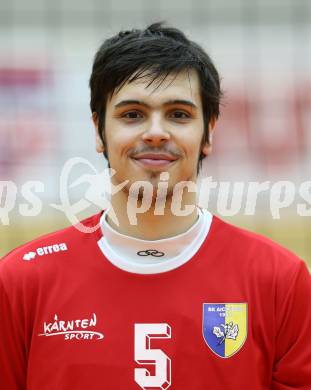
[0,260,27,390]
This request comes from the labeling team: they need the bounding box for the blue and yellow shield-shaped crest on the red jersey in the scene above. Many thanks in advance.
[203,303,247,358]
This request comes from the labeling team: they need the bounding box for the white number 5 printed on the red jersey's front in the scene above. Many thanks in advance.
[134,324,171,389]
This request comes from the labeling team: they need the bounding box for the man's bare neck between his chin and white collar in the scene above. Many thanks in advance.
[107,187,198,240]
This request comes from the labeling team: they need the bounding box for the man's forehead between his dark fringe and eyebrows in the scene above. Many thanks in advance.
[110,69,201,107]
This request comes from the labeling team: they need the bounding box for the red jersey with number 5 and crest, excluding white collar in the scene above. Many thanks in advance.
[0,215,311,390]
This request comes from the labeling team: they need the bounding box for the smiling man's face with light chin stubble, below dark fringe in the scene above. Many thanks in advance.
[95,71,213,198]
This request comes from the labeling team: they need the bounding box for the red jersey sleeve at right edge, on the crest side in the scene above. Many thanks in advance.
[271,262,311,390]
